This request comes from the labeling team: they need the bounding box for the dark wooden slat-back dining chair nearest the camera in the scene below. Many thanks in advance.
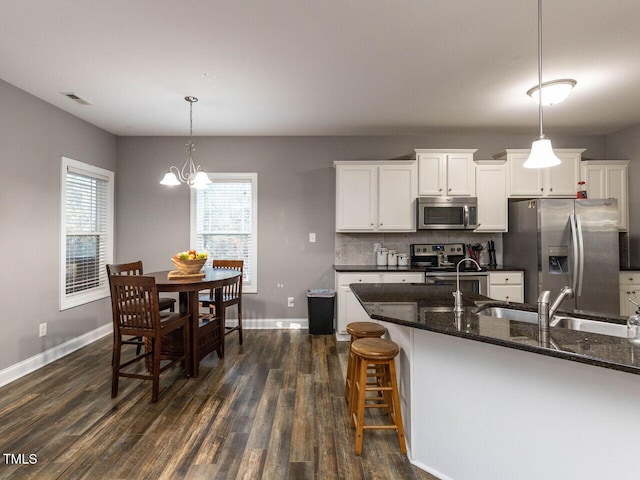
[110,275,191,403]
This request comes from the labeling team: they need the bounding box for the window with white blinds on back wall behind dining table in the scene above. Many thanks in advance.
[191,173,258,293]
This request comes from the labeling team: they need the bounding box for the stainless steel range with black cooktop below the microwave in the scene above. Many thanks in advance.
[410,243,487,295]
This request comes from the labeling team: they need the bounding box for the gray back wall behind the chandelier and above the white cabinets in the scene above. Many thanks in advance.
[116,132,604,319]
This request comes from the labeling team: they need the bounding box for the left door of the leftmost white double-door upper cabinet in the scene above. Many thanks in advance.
[336,164,378,232]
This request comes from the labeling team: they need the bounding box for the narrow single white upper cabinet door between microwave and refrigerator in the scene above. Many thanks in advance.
[474,160,509,232]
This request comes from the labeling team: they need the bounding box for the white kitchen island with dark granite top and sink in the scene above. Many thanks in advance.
[351,284,640,480]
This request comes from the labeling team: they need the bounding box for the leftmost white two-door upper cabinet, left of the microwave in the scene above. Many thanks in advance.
[334,160,418,232]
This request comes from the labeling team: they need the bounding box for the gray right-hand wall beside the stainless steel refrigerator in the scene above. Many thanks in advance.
[604,125,640,268]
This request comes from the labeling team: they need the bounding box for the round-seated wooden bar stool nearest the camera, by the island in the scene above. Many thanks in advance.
[349,338,407,455]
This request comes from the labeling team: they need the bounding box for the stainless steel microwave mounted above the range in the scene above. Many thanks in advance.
[416,197,478,230]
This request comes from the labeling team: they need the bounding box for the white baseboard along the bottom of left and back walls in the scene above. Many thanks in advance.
[0,318,309,387]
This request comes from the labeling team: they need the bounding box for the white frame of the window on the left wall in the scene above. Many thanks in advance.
[59,157,115,311]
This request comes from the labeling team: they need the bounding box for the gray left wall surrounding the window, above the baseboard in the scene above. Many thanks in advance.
[0,80,117,370]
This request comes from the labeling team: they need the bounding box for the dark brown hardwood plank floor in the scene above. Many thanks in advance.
[0,330,437,480]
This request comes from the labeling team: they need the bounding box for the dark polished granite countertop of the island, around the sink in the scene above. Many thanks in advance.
[350,283,640,374]
